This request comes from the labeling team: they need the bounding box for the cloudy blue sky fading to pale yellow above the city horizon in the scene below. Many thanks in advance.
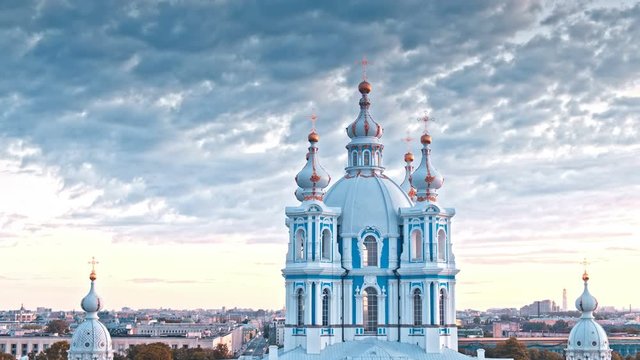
[0,0,640,309]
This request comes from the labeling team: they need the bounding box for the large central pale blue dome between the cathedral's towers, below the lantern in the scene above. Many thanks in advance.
[324,174,413,236]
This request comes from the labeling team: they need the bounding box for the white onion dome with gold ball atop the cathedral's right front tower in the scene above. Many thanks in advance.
[411,133,444,202]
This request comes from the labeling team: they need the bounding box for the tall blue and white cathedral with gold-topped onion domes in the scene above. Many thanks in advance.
[272,80,468,359]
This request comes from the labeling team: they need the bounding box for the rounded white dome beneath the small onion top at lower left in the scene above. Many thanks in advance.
[69,319,113,360]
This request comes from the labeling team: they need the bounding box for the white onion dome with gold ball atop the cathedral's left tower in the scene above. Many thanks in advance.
[296,130,331,201]
